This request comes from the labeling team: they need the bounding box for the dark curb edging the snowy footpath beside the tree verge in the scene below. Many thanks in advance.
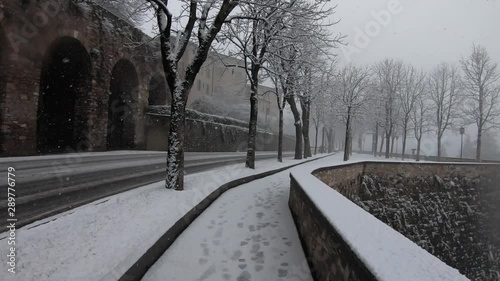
[118,154,334,281]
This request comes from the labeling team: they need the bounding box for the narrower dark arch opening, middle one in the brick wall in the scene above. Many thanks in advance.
[107,59,139,150]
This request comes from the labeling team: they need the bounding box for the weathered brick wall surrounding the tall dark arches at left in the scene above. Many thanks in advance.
[0,0,162,156]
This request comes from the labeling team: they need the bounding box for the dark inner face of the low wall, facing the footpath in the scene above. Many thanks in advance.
[288,178,376,281]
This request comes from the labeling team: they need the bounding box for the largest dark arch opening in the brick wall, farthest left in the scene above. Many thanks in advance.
[37,37,92,153]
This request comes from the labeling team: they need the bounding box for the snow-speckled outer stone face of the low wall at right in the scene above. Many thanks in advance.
[314,162,500,280]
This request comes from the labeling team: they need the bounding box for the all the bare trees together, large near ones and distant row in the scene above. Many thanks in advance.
[97,0,500,190]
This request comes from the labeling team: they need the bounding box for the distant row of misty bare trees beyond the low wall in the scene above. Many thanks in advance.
[315,45,500,161]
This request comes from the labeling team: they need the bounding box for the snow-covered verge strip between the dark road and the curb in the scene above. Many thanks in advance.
[0,155,328,281]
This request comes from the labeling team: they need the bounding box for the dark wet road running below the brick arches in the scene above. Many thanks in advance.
[0,151,292,226]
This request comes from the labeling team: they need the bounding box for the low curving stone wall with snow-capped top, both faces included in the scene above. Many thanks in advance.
[289,161,500,281]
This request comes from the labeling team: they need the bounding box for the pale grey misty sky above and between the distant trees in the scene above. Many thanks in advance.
[134,0,500,159]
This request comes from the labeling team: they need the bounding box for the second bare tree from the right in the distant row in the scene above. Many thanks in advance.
[428,63,462,161]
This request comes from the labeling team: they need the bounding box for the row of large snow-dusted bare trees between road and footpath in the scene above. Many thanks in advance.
[102,0,343,190]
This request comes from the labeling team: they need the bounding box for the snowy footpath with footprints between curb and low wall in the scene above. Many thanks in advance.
[142,168,312,281]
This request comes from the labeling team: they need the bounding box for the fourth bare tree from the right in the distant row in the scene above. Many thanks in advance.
[399,65,425,160]
